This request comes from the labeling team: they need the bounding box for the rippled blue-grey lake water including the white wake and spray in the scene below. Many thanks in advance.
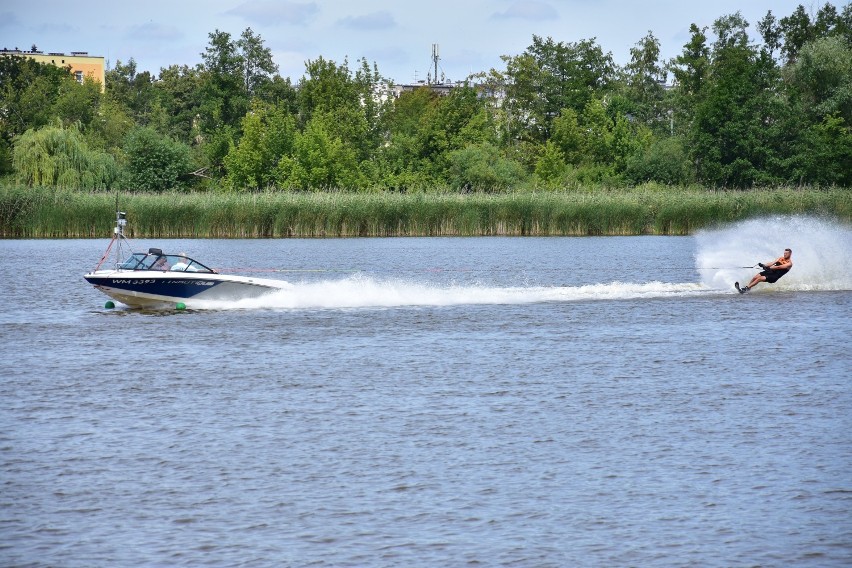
[0,218,852,567]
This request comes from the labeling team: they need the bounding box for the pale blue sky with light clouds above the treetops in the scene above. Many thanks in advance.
[0,0,820,83]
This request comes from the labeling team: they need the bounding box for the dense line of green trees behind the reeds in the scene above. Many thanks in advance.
[0,3,852,192]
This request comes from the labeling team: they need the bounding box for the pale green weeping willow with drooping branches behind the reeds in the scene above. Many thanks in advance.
[12,122,118,189]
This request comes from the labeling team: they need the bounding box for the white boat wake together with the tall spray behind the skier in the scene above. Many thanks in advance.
[185,217,852,309]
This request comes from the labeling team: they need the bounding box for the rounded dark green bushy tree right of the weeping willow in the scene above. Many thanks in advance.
[124,126,193,191]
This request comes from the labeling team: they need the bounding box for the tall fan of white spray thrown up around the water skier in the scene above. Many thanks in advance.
[695,216,852,292]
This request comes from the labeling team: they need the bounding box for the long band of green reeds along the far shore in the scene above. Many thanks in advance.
[0,185,852,238]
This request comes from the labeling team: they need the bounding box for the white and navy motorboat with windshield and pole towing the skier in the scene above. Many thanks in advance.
[83,211,290,308]
